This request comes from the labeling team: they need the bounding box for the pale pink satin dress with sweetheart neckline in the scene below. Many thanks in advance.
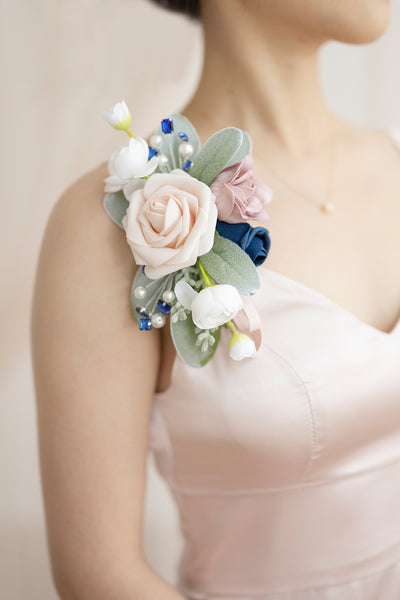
[149,127,400,600]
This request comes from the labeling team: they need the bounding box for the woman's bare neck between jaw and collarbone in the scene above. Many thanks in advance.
[182,0,337,163]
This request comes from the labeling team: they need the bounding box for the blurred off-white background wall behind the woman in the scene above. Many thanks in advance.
[0,0,400,600]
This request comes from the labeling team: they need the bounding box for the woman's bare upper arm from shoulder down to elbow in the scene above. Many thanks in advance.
[31,166,160,596]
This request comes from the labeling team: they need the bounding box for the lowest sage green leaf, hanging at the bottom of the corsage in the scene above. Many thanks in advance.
[170,315,221,368]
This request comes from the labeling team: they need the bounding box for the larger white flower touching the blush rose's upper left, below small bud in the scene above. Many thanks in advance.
[104,137,158,200]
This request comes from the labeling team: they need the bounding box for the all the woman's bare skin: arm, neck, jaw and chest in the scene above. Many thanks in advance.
[31,0,400,600]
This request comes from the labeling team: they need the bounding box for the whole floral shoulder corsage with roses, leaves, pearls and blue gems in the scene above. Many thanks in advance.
[103,100,273,367]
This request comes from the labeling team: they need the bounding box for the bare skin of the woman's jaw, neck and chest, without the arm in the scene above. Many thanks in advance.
[185,0,400,332]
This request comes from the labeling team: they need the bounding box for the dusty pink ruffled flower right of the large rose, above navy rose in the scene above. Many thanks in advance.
[210,154,273,223]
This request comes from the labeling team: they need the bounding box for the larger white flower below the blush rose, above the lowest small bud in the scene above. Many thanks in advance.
[175,279,243,329]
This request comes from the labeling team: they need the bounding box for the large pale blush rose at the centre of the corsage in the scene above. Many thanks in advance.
[122,169,217,279]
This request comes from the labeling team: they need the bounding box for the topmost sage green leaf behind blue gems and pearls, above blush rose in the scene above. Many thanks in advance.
[154,113,201,173]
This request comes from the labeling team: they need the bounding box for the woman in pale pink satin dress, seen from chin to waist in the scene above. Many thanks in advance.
[32,0,400,600]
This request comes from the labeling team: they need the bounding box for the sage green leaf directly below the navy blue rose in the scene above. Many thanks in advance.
[200,234,261,296]
